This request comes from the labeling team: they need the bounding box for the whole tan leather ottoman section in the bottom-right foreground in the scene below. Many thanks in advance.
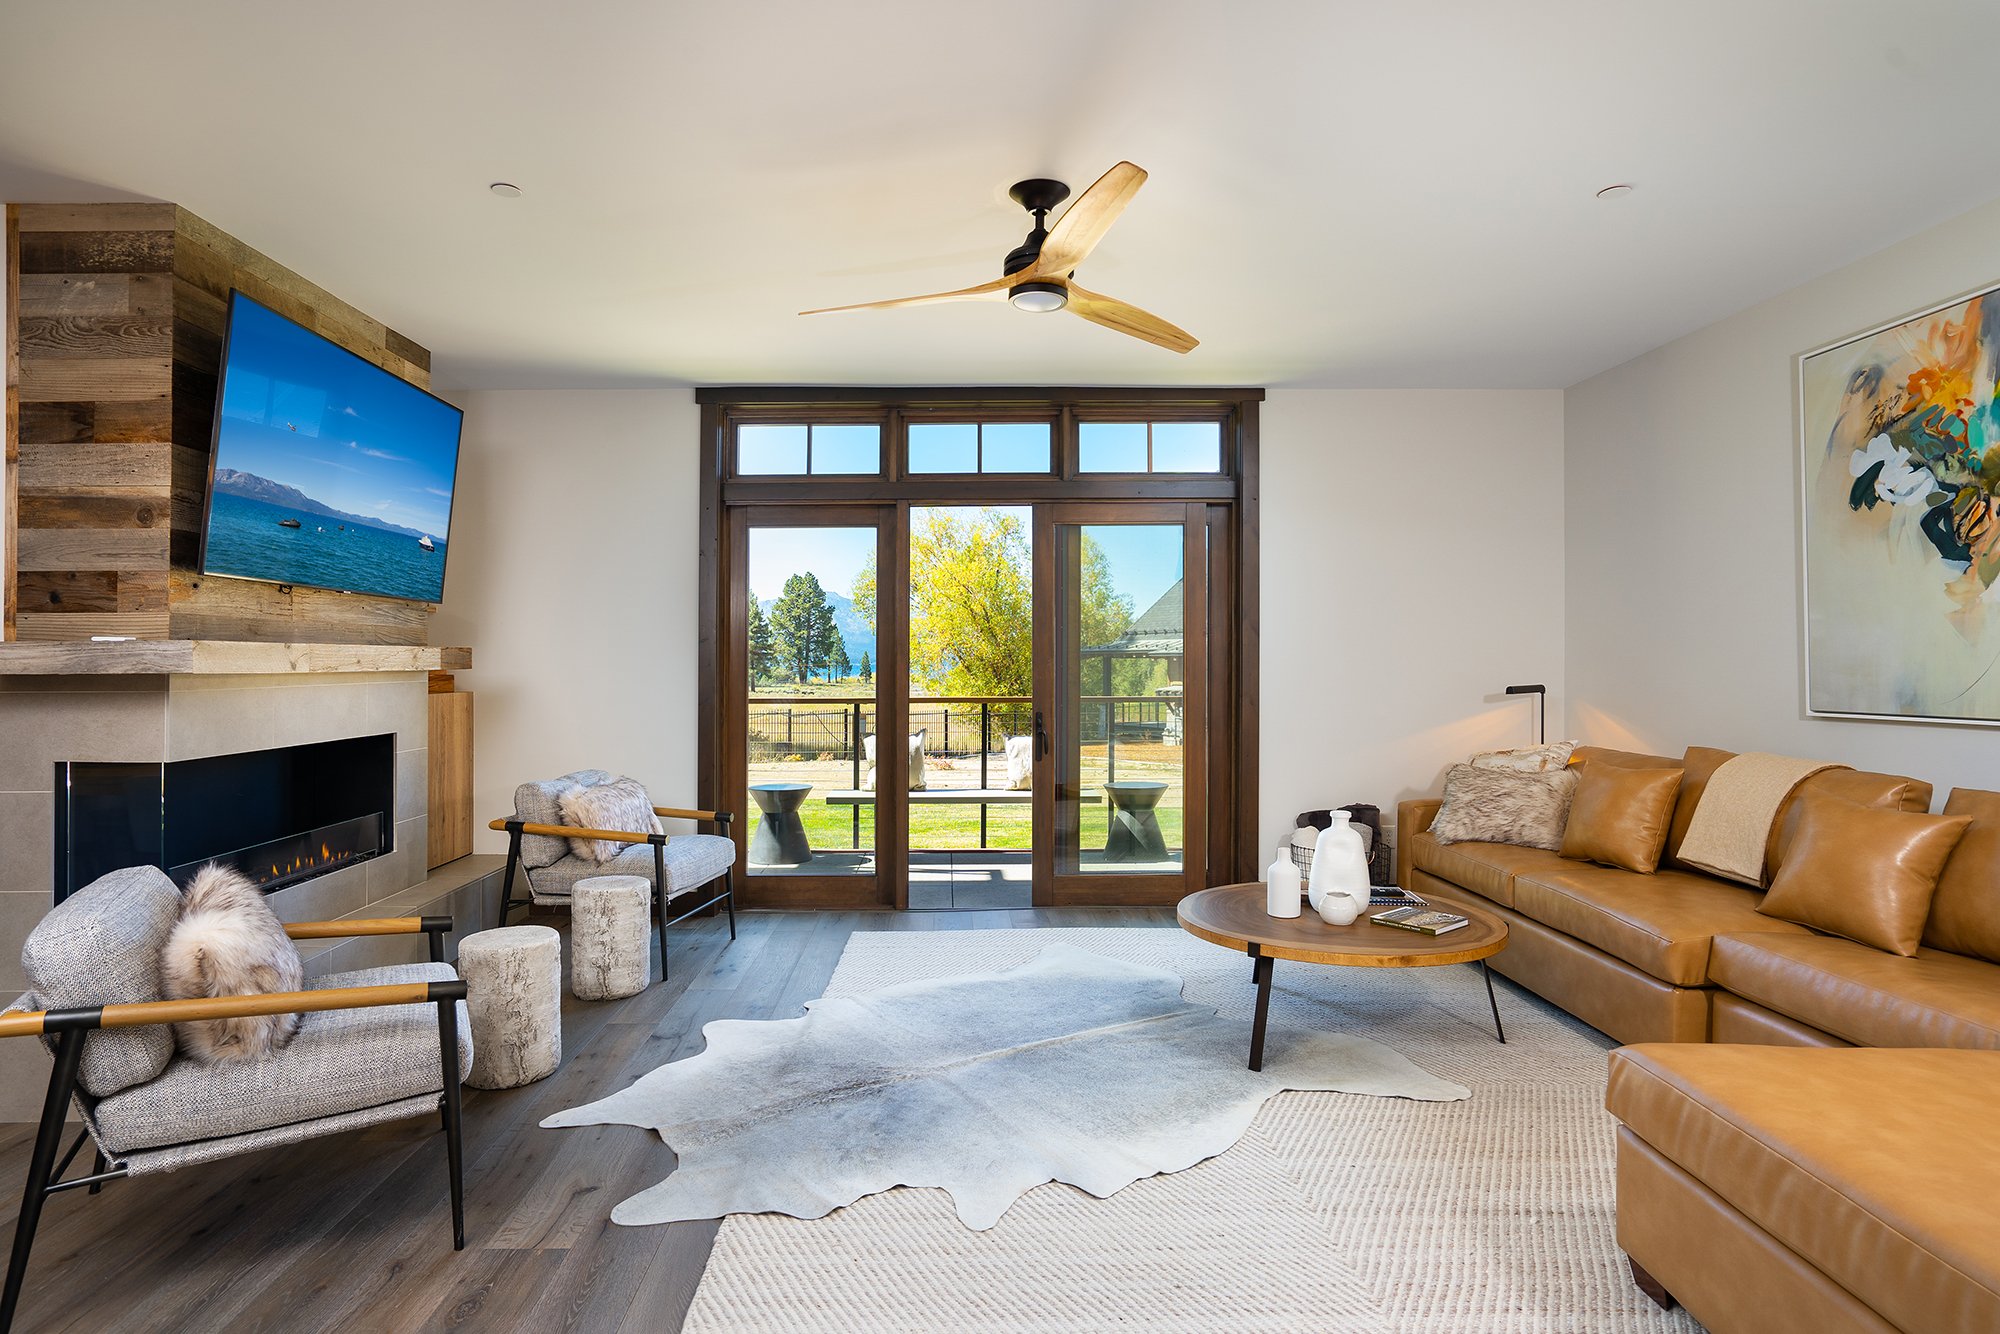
[1606,1044,2000,1334]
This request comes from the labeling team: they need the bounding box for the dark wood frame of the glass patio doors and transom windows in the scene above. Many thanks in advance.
[696,388,1264,908]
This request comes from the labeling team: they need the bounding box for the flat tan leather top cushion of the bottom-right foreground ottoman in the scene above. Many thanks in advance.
[1604,1044,2000,1330]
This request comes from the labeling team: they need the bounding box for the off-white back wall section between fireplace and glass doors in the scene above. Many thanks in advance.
[432,390,700,852]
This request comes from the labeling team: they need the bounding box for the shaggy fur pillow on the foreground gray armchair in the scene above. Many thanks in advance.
[160,862,306,1066]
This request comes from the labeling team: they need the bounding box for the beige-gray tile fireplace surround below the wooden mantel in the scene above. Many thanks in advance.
[0,672,500,1122]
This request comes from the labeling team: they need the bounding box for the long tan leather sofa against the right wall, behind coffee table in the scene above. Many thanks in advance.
[1396,746,2000,1048]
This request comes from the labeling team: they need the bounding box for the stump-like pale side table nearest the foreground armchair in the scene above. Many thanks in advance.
[458,926,562,1088]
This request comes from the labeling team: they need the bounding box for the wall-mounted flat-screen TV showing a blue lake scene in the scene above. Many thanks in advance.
[202,292,464,602]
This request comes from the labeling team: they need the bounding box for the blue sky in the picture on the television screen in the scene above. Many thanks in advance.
[216,296,458,538]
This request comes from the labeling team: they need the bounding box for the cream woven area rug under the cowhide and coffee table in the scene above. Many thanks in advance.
[684,928,1700,1334]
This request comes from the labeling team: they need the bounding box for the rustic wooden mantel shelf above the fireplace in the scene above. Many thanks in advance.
[0,640,472,676]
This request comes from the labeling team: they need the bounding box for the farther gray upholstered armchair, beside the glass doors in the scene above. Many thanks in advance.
[486,768,736,982]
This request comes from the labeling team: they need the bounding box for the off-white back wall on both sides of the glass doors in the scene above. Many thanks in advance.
[432,390,1562,860]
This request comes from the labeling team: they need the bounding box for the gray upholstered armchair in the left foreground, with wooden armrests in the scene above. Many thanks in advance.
[0,866,472,1332]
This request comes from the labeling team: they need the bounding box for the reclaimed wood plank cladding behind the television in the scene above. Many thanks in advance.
[0,204,432,644]
